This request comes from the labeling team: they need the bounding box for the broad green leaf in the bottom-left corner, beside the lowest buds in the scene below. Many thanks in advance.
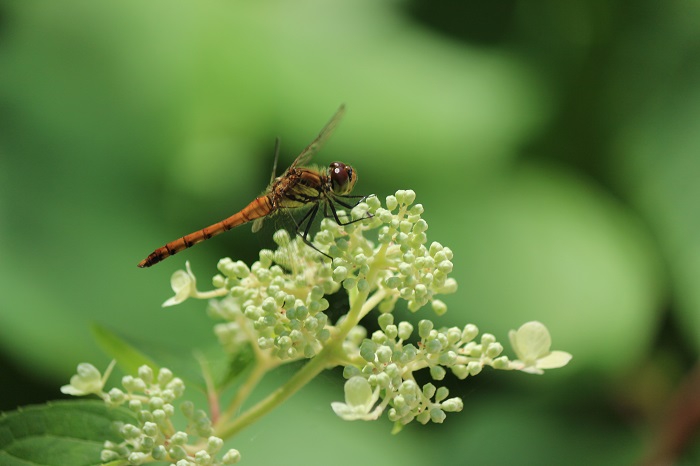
[0,401,135,466]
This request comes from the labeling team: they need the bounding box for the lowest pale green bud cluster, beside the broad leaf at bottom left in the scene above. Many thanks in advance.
[61,363,240,466]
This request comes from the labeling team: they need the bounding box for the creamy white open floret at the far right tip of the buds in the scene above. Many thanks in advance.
[508,321,571,374]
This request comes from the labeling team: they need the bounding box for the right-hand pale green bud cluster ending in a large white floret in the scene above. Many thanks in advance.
[332,314,571,431]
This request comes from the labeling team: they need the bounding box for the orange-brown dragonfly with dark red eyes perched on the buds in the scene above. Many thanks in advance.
[138,105,368,268]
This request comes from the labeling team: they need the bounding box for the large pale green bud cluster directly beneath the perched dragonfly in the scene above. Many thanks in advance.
[172,190,457,361]
